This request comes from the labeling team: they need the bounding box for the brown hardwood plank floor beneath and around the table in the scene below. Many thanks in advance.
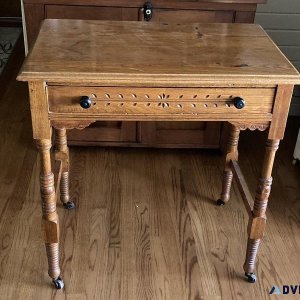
[0,69,300,300]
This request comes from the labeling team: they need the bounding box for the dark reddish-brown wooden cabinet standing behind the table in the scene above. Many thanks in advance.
[23,0,266,148]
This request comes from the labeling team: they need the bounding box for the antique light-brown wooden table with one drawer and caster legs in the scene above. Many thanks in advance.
[18,20,300,288]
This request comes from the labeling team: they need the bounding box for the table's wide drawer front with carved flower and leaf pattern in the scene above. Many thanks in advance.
[48,86,275,119]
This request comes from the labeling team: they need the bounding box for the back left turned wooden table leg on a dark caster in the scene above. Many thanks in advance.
[55,129,75,209]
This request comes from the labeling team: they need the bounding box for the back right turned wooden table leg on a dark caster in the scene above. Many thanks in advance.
[217,124,240,205]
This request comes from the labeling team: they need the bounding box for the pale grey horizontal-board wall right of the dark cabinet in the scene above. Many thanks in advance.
[255,0,300,116]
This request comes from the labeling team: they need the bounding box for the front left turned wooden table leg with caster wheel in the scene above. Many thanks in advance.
[37,140,64,289]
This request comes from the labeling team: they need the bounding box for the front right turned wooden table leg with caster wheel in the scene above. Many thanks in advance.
[244,140,279,282]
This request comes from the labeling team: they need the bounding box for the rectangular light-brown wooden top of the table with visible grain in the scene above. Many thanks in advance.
[18,20,300,86]
